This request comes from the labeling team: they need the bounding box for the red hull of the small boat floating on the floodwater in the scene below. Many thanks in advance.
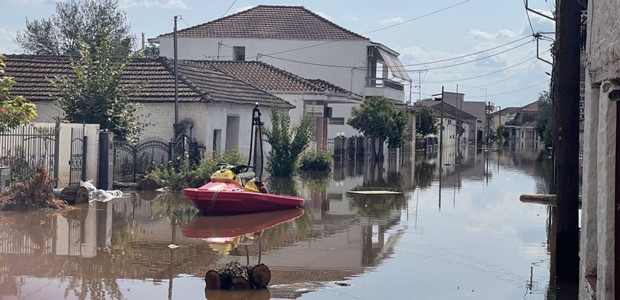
[183,182,305,215]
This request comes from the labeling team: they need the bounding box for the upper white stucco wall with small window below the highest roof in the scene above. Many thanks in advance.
[159,37,370,95]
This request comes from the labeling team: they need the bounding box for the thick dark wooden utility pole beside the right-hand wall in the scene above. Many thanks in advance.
[553,0,581,284]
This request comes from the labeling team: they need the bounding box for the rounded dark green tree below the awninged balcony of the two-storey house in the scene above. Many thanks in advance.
[347,97,409,160]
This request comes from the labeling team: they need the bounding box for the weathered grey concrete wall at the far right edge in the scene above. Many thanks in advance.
[579,0,620,300]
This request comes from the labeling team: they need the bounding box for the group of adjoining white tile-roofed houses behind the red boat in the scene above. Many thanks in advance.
[5,5,413,161]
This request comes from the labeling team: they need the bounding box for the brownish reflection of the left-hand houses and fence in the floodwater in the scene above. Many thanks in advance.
[0,184,412,297]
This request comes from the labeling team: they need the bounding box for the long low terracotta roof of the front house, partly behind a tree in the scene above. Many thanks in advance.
[5,55,292,107]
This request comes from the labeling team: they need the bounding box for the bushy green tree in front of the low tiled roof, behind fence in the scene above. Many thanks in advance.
[51,32,146,141]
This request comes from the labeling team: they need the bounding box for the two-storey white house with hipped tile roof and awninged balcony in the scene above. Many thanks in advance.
[150,5,411,138]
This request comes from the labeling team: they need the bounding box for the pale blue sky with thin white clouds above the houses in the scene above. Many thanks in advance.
[0,0,555,109]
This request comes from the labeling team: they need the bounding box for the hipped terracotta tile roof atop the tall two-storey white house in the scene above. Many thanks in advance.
[160,5,368,40]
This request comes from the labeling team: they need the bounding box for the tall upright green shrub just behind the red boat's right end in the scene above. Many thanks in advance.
[265,108,313,177]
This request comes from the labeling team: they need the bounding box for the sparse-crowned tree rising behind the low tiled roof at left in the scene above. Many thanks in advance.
[15,0,133,57]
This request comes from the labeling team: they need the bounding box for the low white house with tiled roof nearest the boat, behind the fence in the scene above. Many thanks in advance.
[5,55,294,161]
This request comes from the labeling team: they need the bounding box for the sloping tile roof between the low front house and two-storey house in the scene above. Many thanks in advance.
[183,60,361,100]
